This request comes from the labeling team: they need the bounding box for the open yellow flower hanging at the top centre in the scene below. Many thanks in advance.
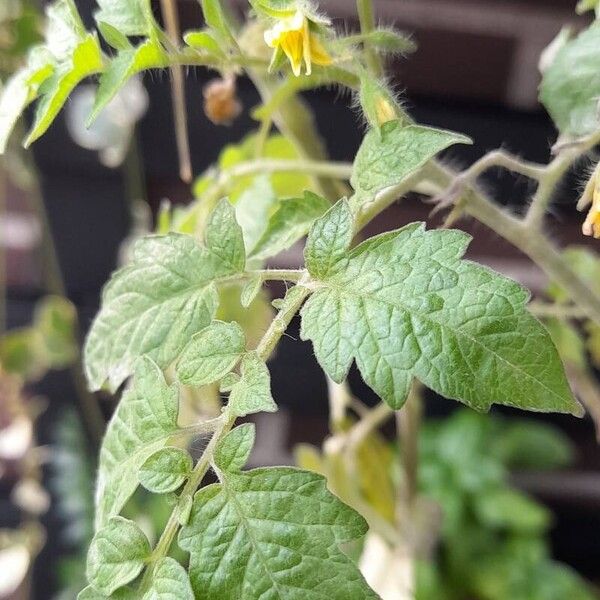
[265,10,332,77]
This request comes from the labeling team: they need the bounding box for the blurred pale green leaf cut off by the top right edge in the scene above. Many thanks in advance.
[540,23,600,138]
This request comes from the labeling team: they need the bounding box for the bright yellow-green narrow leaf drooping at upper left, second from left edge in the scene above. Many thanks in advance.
[25,34,103,147]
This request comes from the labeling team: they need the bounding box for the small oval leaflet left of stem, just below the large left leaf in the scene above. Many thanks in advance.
[177,321,246,387]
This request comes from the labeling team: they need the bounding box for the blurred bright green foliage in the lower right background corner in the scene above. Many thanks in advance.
[416,410,593,600]
